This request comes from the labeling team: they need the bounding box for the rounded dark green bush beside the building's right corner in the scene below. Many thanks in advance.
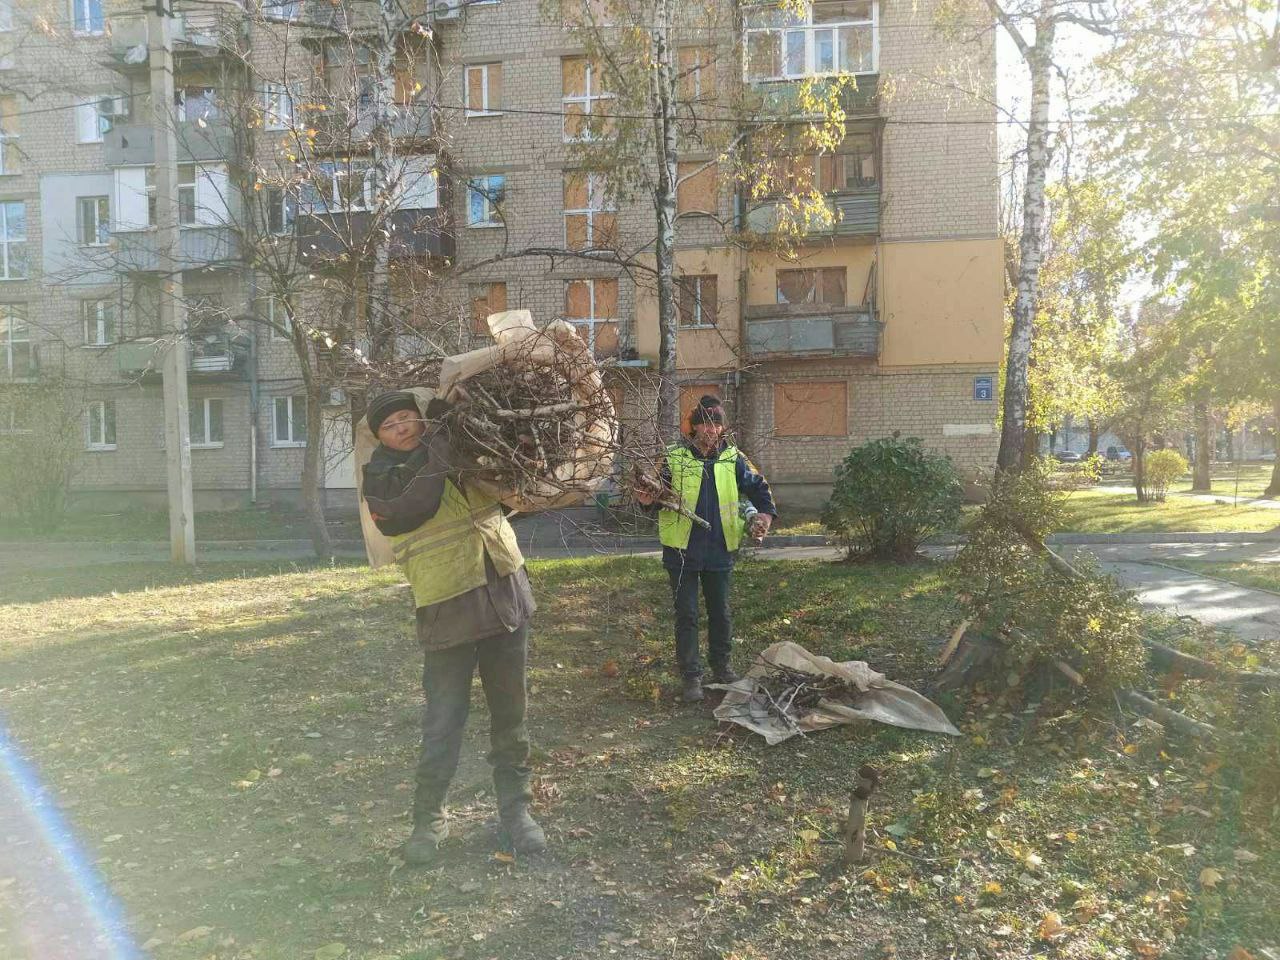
[822,433,963,559]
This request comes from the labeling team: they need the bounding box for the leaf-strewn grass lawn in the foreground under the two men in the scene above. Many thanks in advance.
[0,558,1280,960]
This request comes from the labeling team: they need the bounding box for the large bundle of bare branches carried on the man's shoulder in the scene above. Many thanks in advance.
[447,338,616,499]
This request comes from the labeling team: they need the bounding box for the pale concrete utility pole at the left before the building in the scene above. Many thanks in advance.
[147,0,196,563]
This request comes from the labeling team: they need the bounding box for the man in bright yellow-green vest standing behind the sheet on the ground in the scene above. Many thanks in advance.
[635,396,777,703]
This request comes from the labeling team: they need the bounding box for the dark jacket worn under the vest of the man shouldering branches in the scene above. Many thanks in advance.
[362,424,538,649]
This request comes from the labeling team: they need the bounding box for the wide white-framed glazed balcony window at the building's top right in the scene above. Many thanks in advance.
[745,0,879,81]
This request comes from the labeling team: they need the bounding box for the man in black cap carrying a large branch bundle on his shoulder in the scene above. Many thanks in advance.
[362,392,547,864]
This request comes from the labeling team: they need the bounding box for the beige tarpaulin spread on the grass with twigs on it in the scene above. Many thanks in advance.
[709,643,960,746]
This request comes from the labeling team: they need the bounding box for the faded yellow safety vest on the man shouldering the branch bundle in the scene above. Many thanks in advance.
[390,479,525,607]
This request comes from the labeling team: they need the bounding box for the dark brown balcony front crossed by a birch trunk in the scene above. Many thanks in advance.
[294,207,457,262]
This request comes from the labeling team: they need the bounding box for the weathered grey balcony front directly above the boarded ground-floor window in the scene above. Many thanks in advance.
[746,303,883,360]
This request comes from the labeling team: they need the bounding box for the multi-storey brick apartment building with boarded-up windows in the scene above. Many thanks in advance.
[0,0,1004,506]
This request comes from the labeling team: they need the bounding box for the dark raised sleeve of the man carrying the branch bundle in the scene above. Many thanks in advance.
[364,425,454,536]
